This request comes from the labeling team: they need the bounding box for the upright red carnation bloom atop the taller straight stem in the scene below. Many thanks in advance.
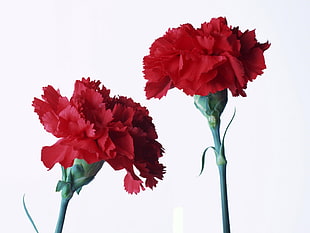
[143,17,270,99]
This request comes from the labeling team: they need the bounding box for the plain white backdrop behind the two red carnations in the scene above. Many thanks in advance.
[0,0,310,233]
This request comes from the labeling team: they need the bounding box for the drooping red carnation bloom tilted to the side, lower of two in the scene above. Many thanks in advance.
[33,78,164,193]
